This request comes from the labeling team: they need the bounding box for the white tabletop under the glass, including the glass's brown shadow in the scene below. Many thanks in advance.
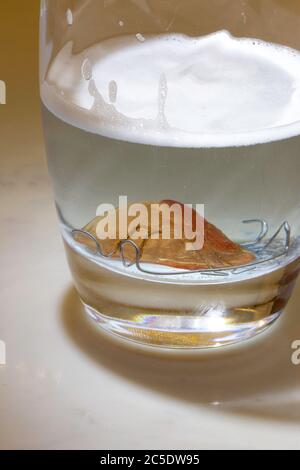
[0,129,300,450]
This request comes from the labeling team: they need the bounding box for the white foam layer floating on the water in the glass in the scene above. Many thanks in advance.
[41,31,300,147]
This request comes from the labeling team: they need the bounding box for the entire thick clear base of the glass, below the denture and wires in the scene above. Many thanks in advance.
[66,243,299,349]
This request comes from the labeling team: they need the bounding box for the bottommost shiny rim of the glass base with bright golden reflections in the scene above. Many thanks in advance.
[84,303,281,349]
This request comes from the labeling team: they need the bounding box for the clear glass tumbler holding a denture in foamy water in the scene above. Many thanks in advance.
[40,0,300,348]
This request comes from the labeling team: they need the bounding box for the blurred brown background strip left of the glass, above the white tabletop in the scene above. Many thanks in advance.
[0,0,41,167]
